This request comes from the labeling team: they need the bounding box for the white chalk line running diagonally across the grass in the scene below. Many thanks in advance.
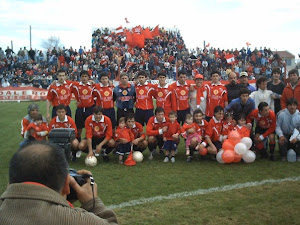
[108,177,300,209]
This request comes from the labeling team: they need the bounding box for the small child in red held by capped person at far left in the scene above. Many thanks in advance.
[27,114,49,141]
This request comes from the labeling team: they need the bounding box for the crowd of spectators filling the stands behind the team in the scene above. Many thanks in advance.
[0,28,285,88]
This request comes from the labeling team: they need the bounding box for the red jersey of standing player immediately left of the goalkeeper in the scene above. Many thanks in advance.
[93,83,114,109]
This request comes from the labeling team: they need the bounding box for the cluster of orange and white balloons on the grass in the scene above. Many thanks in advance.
[217,131,256,163]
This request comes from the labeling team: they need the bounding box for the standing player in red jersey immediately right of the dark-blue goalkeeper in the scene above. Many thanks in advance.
[135,70,154,126]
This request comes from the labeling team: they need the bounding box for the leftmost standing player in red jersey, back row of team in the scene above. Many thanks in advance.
[46,70,72,121]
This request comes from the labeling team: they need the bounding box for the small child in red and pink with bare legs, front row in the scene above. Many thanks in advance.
[182,114,201,156]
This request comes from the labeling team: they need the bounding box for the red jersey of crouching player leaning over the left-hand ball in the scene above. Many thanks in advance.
[85,115,113,140]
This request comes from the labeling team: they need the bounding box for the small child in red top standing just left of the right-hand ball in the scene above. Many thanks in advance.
[115,117,134,164]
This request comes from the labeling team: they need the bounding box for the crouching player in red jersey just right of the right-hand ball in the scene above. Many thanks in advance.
[146,107,169,160]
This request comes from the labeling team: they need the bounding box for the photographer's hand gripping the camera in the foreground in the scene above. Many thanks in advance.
[70,170,98,204]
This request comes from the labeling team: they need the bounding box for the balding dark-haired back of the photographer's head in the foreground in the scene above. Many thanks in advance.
[9,142,68,192]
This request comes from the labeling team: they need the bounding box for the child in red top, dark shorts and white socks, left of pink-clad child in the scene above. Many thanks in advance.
[162,111,181,163]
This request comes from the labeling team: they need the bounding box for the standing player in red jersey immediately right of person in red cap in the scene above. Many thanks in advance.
[205,70,228,121]
